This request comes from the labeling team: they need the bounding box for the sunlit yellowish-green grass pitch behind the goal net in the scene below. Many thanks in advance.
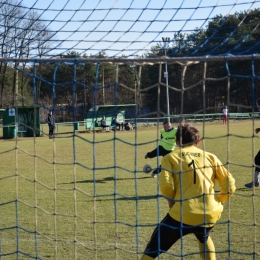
[0,120,260,260]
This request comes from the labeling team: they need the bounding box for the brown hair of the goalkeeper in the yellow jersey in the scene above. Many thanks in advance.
[176,123,200,146]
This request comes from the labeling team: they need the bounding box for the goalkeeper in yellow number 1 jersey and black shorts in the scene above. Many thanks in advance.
[141,123,236,260]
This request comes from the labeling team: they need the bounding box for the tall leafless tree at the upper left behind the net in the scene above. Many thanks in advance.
[0,0,53,106]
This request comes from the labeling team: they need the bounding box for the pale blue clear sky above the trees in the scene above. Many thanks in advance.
[16,0,260,57]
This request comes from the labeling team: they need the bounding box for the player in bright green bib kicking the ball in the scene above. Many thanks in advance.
[145,120,177,177]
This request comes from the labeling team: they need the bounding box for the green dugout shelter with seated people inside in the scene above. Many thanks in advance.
[84,104,136,129]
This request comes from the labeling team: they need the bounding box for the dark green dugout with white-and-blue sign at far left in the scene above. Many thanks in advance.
[3,106,40,139]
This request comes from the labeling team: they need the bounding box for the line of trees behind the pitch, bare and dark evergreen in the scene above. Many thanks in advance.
[0,0,260,118]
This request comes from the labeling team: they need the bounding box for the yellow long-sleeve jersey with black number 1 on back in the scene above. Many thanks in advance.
[160,145,236,227]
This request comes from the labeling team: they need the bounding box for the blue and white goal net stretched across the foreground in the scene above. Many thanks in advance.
[0,0,260,260]
